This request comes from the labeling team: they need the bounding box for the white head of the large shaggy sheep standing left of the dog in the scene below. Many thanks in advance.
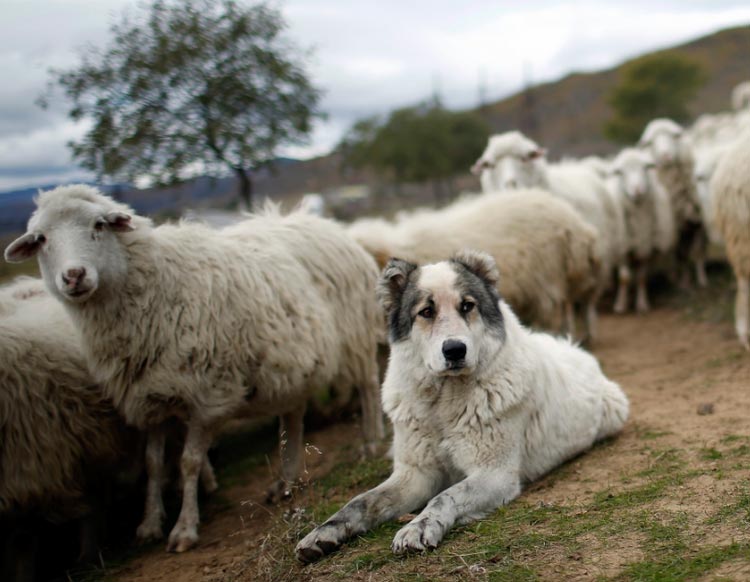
[5,185,134,303]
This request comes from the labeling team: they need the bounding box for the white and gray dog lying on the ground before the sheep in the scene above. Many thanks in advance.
[297,251,628,563]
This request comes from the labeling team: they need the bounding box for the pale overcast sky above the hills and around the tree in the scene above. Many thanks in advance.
[0,0,750,191]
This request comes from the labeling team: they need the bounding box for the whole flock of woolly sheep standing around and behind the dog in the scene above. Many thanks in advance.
[0,83,750,576]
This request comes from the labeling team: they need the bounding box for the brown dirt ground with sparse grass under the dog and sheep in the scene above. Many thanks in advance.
[89,288,750,582]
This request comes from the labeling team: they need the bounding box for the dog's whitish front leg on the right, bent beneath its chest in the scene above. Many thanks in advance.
[391,466,521,554]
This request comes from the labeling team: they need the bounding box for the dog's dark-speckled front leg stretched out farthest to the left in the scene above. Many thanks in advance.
[296,463,442,564]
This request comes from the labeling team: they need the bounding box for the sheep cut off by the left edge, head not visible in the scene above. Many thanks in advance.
[0,278,127,579]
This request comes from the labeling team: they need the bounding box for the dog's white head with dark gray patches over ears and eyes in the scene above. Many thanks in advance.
[378,251,505,376]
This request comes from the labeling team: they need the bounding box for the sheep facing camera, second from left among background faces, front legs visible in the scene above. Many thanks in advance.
[608,148,675,313]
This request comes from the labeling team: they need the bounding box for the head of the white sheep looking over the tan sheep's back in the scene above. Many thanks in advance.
[471,131,547,190]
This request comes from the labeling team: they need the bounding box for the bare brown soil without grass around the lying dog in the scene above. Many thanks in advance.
[97,307,750,582]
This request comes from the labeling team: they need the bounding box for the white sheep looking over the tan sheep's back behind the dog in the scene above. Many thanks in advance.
[473,131,625,302]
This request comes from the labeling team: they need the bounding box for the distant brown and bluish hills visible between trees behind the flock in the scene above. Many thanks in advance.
[0,26,750,234]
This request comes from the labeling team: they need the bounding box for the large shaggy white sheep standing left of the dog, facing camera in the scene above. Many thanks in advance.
[5,185,384,552]
